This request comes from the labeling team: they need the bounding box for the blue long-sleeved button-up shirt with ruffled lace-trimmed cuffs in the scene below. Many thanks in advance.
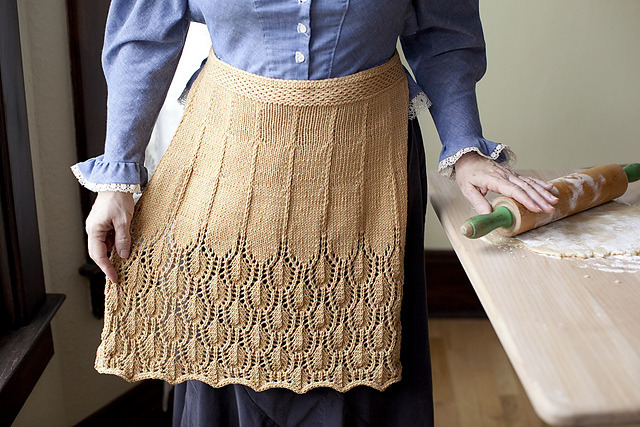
[72,0,508,192]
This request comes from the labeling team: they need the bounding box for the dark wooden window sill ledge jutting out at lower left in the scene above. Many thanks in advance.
[0,294,64,426]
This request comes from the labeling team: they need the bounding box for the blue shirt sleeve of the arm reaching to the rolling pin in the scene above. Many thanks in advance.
[400,0,515,176]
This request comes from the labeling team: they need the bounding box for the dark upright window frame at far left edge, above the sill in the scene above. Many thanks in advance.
[0,0,45,330]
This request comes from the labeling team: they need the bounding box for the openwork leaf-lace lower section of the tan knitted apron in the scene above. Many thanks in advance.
[96,227,402,393]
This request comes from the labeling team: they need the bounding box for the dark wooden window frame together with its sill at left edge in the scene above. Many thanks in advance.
[0,0,64,425]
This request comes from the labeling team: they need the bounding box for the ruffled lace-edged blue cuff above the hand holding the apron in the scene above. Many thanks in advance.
[71,154,148,195]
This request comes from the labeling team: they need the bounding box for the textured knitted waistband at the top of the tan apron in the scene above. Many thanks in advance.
[202,48,405,106]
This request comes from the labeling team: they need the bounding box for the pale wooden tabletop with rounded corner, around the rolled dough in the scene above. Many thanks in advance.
[429,170,640,424]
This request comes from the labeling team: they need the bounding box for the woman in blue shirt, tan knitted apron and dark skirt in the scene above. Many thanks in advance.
[72,0,555,426]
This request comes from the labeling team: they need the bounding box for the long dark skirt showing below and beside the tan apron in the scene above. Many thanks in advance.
[173,119,433,427]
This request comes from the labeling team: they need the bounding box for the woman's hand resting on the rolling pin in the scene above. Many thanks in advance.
[455,152,558,214]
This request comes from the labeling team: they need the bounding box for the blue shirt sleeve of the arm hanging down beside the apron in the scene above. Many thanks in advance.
[71,0,189,193]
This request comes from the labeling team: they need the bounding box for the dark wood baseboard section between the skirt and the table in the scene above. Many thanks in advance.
[424,250,487,317]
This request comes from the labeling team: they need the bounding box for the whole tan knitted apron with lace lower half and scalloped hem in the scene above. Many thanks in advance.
[95,47,408,393]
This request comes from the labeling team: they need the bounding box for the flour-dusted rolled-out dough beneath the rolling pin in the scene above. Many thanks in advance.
[485,197,640,272]
